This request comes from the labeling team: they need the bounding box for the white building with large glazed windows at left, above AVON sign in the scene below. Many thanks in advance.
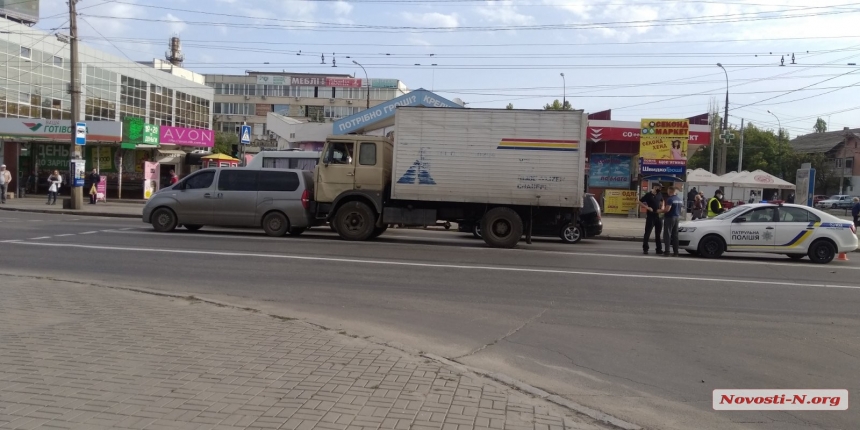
[0,19,214,196]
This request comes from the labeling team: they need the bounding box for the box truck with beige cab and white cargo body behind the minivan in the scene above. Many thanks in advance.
[314,107,587,248]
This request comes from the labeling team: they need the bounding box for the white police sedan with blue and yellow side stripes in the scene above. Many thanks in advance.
[678,203,858,264]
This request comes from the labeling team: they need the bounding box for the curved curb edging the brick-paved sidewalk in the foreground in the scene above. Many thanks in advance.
[0,273,643,430]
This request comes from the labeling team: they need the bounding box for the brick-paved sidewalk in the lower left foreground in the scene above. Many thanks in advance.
[0,275,620,430]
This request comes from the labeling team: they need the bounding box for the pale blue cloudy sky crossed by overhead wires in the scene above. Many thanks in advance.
[37,0,860,136]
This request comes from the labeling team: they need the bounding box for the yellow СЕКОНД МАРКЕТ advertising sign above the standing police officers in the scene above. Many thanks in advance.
[639,119,690,165]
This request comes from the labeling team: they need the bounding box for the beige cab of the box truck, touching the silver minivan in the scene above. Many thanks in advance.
[314,135,393,240]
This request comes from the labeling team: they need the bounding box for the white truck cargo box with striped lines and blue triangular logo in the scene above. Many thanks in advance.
[391,107,587,208]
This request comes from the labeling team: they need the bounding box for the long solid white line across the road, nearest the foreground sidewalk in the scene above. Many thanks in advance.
[15,242,860,290]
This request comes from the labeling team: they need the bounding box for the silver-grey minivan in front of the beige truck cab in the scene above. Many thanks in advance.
[143,167,314,236]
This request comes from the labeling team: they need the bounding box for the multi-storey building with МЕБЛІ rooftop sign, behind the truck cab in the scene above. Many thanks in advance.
[206,72,409,148]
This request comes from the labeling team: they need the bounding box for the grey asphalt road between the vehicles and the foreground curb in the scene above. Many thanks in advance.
[0,212,860,430]
